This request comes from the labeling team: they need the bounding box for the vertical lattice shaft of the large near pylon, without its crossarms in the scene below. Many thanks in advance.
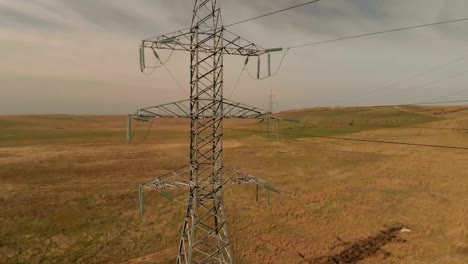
[185,0,232,263]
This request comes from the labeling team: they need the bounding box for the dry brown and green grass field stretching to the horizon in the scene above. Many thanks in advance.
[0,107,468,264]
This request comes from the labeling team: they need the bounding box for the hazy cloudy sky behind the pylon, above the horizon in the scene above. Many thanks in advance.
[0,0,468,114]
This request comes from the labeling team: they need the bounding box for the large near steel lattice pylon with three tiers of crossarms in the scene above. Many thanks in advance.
[129,0,280,263]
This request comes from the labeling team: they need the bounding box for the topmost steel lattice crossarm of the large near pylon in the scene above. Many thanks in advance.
[140,28,277,56]
